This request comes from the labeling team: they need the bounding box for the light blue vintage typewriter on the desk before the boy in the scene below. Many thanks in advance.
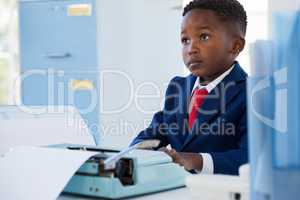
[60,142,187,199]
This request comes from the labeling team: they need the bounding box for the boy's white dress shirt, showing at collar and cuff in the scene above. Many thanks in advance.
[192,65,234,174]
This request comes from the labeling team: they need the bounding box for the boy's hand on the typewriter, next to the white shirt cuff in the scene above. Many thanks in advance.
[159,147,203,171]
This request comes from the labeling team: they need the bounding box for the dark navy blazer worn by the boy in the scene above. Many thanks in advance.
[131,62,248,175]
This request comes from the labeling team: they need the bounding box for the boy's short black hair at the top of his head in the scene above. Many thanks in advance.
[183,0,247,35]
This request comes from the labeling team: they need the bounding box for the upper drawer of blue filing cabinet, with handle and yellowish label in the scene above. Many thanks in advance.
[20,0,98,70]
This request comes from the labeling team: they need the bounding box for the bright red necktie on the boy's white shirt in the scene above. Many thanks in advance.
[189,88,208,130]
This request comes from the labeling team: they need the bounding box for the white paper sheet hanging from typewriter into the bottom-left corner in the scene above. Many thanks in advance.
[0,146,97,200]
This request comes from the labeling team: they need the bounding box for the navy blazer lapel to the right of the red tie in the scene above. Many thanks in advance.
[181,63,247,151]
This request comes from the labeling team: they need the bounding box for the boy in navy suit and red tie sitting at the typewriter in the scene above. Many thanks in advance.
[131,0,248,174]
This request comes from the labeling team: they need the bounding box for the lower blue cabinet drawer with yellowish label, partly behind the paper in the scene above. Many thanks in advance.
[22,70,100,135]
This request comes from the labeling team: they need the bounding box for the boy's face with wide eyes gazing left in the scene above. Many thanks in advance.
[181,9,242,82]
